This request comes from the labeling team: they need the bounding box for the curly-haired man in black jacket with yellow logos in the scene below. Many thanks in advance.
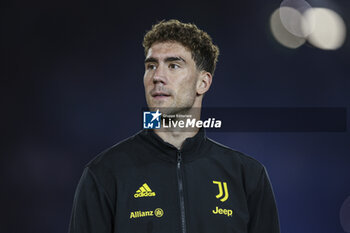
[70,20,279,233]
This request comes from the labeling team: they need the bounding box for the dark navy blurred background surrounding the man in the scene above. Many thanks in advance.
[0,0,350,233]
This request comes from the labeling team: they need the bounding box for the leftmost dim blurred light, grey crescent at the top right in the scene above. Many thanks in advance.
[270,7,306,49]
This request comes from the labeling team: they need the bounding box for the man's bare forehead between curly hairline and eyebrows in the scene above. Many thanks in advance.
[146,42,191,59]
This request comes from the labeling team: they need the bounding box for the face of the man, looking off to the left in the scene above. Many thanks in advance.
[143,42,199,114]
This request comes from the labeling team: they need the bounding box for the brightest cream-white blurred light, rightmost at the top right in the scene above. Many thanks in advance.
[303,8,346,50]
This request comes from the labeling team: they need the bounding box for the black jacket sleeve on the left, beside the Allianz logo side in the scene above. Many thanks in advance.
[69,167,113,233]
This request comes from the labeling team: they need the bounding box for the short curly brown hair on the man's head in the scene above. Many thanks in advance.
[142,19,219,75]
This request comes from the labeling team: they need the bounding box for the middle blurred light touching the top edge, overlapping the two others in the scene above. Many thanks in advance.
[280,0,312,37]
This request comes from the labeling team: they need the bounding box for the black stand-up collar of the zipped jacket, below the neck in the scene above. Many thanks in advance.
[139,128,207,162]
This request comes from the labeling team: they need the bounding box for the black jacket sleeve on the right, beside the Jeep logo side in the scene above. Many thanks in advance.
[248,168,280,233]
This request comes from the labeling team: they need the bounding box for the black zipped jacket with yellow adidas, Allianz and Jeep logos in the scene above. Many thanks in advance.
[70,129,279,233]
